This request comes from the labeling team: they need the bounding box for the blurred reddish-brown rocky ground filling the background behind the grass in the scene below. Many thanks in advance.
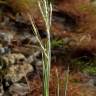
[0,0,96,96]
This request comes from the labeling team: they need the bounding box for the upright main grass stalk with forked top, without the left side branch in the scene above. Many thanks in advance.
[39,0,52,96]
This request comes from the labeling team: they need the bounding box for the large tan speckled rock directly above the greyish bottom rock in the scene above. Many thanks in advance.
[5,64,34,82]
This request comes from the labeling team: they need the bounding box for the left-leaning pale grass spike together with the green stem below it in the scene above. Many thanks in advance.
[29,12,50,96]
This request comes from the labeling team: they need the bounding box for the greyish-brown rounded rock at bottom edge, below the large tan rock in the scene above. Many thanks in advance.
[9,83,29,96]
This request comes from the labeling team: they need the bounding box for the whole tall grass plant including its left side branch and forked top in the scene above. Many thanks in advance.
[28,0,52,96]
